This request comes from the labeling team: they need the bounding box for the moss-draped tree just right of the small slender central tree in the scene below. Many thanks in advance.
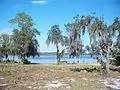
[65,15,85,62]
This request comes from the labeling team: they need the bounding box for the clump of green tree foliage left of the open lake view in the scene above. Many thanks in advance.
[0,12,40,64]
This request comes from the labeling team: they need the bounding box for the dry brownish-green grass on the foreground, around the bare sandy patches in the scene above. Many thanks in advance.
[0,63,118,90]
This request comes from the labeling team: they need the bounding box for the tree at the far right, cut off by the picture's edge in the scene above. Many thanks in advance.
[110,17,120,65]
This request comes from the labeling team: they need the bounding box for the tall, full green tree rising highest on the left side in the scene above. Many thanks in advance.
[9,12,40,63]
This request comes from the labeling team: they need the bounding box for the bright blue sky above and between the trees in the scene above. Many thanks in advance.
[0,0,120,52]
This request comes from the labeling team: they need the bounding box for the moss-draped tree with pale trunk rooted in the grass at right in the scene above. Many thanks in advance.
[91,18,112,73]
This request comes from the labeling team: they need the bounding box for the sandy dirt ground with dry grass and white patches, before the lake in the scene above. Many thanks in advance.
[0,64,120,90]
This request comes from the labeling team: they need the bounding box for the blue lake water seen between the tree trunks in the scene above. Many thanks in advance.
[28,55,96,64]
